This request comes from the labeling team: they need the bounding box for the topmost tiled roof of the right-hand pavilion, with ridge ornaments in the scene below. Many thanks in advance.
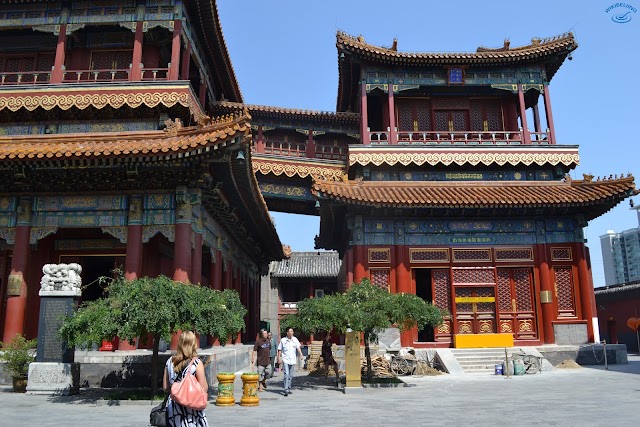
[336,31,578,59]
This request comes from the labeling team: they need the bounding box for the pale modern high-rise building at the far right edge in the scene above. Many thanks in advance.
[600,206,640,286]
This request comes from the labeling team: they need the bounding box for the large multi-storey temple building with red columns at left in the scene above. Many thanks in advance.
[0,0,284,349]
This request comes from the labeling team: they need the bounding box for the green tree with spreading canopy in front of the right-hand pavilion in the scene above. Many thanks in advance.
[281,279,445,378]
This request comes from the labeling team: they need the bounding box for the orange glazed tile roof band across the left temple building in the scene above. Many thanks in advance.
[0,115,250,160]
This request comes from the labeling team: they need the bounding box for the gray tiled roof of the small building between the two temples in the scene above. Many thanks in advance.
[271,252,342,278]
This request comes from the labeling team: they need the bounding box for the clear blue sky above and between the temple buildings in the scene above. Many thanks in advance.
[218,0,640,286]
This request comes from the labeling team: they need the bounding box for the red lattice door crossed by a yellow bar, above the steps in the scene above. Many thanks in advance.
[453,267,496,334]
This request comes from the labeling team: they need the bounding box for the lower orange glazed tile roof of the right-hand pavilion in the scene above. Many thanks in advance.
[313,176,638,208]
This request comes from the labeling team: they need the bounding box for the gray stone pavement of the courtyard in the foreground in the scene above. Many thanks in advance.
[0,356,640,427]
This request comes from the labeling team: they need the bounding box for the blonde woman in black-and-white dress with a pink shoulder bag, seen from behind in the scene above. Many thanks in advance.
[162,331,209,427]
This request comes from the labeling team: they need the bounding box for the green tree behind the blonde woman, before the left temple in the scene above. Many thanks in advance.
[60,276,247,395]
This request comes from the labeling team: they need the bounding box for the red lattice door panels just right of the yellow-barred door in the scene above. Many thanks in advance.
[497,268,538,339]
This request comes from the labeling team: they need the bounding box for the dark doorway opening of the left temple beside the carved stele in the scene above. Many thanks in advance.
[60,255,124,302]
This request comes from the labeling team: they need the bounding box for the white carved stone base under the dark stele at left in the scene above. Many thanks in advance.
[27,362,80,396]
